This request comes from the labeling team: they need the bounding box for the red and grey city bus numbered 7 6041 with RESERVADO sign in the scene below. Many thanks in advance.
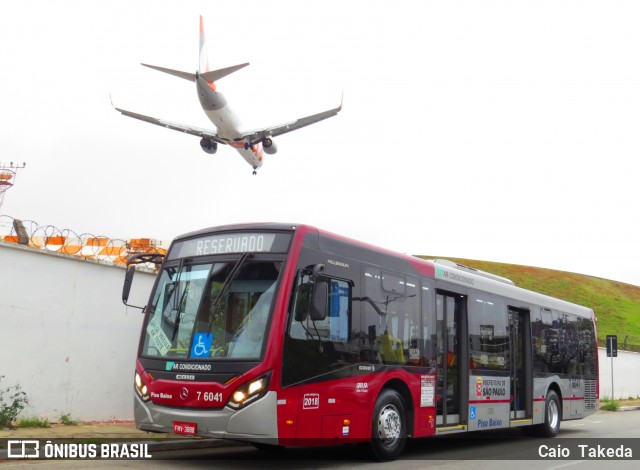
[123,224,598,460]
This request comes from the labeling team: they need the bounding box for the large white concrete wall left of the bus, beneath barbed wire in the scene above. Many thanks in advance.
[0,242,154,421]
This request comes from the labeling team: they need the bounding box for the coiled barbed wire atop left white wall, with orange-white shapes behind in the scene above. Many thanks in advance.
[0,215,167,268]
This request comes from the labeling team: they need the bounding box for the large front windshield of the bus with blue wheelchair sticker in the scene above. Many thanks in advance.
[142,256,281,360]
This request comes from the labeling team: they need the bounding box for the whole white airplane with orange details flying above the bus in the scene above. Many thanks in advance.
[114,16,342,175]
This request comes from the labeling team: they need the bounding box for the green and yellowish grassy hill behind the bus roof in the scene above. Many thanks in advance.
[422,256,640,351]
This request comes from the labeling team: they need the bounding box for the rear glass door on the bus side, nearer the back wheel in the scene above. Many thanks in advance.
[509,307,532,420]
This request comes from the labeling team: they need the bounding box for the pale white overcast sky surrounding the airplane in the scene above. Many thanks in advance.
[0,0,640,285]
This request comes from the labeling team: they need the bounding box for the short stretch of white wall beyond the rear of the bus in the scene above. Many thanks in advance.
[598,348,640,399]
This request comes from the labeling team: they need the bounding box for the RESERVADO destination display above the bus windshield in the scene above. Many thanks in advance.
[168,232,291,259]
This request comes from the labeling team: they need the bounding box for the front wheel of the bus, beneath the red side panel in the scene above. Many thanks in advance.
[369,388,407,461]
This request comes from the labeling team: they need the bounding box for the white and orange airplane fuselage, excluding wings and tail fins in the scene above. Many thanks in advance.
[196,76,264,170]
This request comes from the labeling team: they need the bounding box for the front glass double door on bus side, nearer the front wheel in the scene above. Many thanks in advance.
[436,290,468,426]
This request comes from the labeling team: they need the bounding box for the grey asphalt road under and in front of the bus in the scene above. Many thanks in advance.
[2,411,640,470]
